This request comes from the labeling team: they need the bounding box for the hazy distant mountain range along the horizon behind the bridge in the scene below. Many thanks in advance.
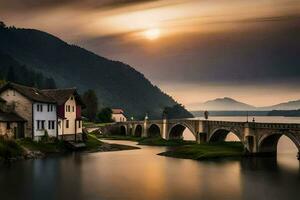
[194,97,300,111]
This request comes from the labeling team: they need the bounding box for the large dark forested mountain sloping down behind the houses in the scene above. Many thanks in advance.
[0,23,192,118]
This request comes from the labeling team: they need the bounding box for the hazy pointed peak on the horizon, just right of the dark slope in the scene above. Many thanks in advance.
[192,97,256,111]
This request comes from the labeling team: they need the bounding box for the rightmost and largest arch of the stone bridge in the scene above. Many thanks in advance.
[258,132,300,154]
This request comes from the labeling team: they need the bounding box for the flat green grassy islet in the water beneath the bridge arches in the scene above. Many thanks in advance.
[159,142,245,160]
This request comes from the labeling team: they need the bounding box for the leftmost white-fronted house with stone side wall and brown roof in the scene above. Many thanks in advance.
[0,83,58,140]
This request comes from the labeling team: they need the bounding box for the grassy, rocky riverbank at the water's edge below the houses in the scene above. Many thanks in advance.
[0,134,139,161]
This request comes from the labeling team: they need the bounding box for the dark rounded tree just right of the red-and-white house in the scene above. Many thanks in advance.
[82,90,98,121]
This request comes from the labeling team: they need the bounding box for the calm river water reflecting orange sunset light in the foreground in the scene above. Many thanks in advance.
[0,116,300,200]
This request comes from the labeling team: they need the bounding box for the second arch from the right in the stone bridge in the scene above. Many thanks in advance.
[208,128,243,143]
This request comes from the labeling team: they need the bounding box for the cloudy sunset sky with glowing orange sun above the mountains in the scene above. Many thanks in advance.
[0,0,300,110]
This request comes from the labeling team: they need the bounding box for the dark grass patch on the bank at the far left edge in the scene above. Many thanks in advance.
[0,138,23,160]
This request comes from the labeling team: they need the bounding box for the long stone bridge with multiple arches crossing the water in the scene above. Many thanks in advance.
[115,119,300,159]
